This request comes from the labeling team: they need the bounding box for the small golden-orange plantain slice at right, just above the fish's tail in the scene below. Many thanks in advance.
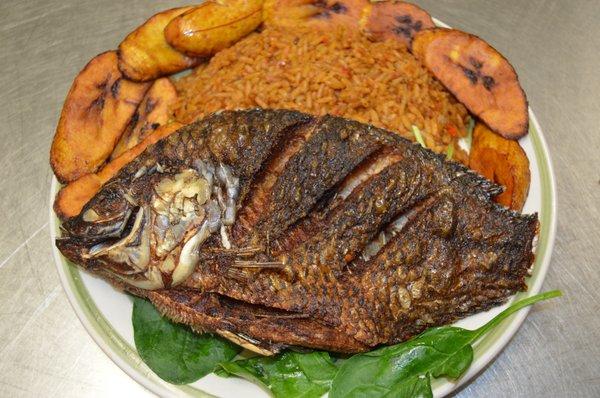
[469,123,531,211]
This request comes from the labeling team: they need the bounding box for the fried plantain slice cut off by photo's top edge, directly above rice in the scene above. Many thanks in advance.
[263,0,369,29]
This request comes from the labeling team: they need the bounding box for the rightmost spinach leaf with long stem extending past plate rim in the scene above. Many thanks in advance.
[329,291,561,398]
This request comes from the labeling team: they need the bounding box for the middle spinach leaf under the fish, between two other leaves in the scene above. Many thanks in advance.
[216,352,337,398]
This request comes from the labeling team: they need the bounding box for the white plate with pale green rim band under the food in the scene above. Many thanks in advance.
[50,8,556,397]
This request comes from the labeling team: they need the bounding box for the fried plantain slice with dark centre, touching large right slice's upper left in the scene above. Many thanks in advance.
[361,0,435,47]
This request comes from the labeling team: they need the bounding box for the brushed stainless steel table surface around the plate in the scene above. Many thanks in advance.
[0,0,600,397]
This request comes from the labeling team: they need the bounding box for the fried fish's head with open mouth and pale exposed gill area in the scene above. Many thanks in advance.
[56,160,239,290]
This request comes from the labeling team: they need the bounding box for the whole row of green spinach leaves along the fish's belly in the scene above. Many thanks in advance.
[133,290,561,398]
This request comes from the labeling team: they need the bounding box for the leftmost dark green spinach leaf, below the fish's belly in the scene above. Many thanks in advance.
[132,297,241,384]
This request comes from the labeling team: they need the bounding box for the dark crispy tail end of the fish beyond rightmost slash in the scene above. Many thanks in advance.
[342,188,538,346]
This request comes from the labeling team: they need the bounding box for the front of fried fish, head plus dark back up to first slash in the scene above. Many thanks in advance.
[56,110,311,292]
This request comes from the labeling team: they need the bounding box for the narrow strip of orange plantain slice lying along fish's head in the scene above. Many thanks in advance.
[54,122,183,220]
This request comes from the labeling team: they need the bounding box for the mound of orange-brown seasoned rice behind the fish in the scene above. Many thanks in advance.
[175,28,468,161]
